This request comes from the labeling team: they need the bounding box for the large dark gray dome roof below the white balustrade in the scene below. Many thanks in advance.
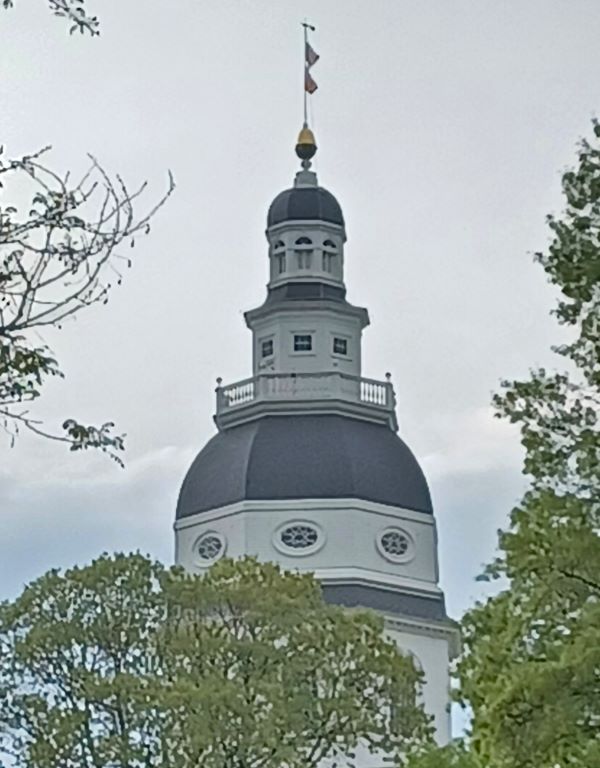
[177,415,432,519]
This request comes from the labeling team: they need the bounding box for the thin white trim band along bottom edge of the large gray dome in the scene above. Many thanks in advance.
[173,498,435,531]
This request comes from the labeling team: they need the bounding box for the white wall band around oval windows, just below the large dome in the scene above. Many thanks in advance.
[175,499,439,594]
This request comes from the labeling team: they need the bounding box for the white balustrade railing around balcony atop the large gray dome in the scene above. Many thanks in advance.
[217,372,396,416]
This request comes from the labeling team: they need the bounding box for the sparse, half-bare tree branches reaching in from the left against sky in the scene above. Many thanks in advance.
[0,6,174,463]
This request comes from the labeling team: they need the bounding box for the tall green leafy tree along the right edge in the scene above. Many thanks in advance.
[459,123,600,768]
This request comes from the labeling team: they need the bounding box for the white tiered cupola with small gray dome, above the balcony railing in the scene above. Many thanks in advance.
[245,127,369,388]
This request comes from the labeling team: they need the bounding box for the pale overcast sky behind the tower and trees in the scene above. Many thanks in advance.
[0,0,600,636]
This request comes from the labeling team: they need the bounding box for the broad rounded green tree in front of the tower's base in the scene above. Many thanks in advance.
[0,554,430,768]
